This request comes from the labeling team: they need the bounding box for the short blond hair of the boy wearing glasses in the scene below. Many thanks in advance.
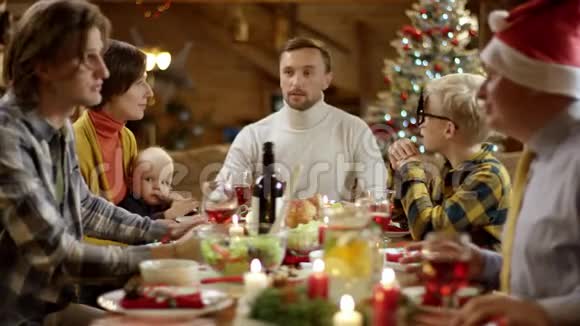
[425,74,490,144]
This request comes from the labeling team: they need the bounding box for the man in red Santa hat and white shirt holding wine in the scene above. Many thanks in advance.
[406,0,580,325]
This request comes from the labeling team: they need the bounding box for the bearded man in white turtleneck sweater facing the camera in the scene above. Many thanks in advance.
[219,38,387,200]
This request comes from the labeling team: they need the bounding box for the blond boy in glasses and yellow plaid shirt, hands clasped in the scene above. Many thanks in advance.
[389,74,510,247]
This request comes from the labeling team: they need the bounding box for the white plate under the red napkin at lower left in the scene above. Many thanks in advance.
[97,289,234,318]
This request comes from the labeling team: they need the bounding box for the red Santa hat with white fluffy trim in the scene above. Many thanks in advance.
[481,0,580,99]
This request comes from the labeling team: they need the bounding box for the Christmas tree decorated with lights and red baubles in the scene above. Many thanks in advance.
[364,0,482,156]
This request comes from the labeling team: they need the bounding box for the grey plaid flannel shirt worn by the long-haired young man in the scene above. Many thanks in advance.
[0,94,168,325]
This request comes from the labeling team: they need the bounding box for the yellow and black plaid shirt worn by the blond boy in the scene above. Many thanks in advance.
[397,144,511,247]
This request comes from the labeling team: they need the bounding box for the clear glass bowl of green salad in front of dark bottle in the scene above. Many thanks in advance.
[201,230,288,276]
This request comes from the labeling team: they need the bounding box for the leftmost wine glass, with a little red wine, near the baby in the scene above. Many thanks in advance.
[203,181,238,224]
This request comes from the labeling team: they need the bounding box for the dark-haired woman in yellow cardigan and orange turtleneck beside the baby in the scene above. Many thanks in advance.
[74,40,153,204]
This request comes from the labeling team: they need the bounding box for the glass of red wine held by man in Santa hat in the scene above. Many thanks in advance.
[422,232,471,308]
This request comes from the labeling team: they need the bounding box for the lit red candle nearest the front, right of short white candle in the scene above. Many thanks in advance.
[373,268,399,326]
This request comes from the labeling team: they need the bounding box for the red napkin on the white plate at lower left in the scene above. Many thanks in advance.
[121,292,204,309]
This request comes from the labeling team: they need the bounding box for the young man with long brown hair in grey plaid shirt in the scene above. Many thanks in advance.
[0,0,198,325]
